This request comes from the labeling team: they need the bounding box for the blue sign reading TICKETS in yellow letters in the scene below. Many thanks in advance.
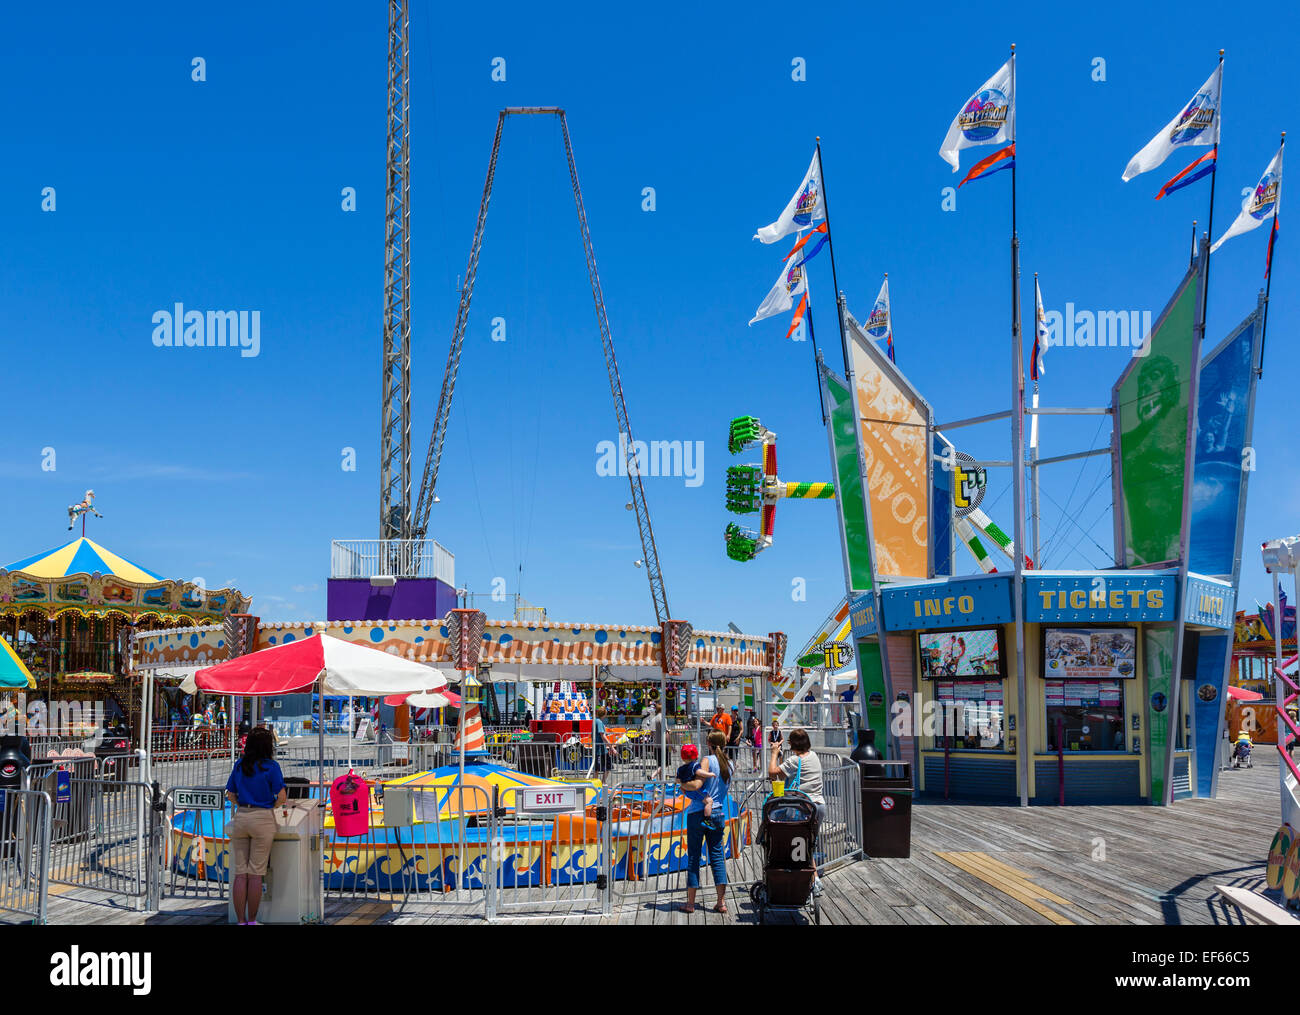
[1024,572,1178,624]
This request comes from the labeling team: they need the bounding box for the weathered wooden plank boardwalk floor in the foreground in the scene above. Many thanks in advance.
[17,747,1279,927]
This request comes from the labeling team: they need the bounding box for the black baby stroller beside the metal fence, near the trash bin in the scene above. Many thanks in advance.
[750,793,822,924]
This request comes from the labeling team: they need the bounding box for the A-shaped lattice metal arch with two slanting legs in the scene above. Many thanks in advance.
[411,105,671,624]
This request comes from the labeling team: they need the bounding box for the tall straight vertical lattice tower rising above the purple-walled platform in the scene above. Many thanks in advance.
[380,0,411,539]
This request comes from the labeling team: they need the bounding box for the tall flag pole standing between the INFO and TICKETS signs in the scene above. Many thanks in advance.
[1003,43,1030,807]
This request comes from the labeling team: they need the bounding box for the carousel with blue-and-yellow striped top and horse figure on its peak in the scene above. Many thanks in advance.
[0,493,250,728]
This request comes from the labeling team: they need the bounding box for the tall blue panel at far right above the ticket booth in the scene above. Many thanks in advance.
[1188,311,1260,576]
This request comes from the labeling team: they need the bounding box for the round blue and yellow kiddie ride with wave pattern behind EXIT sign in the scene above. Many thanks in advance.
[166,759,753,892]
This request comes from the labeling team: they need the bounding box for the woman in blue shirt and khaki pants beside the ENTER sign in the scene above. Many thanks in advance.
[226,726,287,927]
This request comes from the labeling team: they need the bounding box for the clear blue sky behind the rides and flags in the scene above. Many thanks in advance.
[0,0,1300,641]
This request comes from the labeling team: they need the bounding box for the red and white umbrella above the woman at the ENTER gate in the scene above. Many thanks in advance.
[182,634,447,697]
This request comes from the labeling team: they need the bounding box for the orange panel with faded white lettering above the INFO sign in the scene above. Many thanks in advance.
[844,312,932,578]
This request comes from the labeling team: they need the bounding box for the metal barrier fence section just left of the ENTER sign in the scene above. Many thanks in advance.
[49,777,152,908]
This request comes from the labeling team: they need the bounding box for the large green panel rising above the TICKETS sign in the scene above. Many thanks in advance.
[1113,269,1200,568]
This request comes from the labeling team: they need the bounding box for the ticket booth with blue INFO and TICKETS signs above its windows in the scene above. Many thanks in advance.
[881,571,1232,804]
